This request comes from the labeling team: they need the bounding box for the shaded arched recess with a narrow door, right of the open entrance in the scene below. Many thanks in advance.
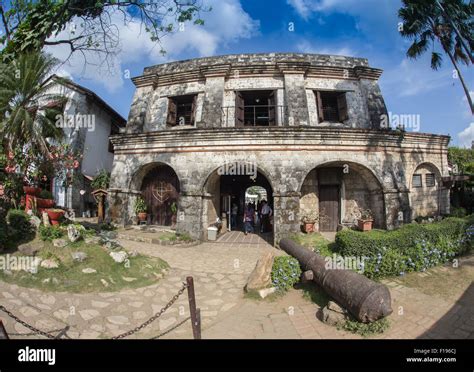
[300,161,386,231]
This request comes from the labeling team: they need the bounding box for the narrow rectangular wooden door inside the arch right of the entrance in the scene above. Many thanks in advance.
[319,185,340,231]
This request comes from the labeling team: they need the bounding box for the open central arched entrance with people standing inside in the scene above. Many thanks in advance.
[203,164,274,241]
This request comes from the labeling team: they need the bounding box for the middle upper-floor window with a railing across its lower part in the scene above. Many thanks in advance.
[235,90,277,127]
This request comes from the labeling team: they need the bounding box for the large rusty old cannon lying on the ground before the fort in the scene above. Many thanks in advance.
[280,239,392,323]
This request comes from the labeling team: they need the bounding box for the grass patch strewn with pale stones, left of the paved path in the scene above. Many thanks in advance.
[0,241,168,293]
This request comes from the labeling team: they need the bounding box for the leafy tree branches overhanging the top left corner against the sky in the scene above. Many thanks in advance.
[0,0,207,67]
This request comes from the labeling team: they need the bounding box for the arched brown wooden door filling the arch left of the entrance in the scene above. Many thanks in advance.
[142,167,179,226]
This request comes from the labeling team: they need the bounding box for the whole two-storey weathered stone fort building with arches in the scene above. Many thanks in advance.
[109,53,449,241]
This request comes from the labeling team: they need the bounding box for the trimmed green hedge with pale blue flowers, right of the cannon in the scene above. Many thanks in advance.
[335,216,474,278]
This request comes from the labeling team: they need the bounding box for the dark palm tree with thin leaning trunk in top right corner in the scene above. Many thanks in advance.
[398,0,474,114]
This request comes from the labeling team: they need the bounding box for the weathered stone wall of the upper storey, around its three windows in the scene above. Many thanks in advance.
[127,53,386,133]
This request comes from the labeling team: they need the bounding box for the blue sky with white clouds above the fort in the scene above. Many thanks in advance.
[43,0,474,146]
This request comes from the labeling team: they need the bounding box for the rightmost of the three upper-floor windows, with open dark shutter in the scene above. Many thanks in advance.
[315,91,349,123]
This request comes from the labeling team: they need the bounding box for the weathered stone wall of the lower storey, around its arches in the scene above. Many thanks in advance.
[109,127,447,243]
